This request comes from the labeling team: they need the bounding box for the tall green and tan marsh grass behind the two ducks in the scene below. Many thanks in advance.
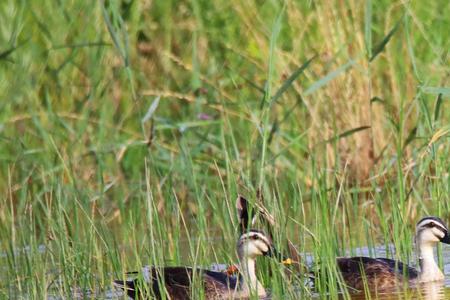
[0,0,450,299]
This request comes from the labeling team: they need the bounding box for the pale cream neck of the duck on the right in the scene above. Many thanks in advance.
[418,240,444,282]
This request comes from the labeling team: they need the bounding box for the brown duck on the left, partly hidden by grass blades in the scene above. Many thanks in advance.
[113,229,284,300]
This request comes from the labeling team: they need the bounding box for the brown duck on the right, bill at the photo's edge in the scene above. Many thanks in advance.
[337,217,450,290]
